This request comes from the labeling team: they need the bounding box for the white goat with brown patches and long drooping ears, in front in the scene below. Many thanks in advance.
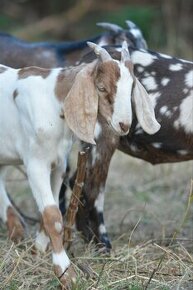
[0,43,160,285]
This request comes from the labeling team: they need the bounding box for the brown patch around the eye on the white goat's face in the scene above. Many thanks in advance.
[95,61,120,119]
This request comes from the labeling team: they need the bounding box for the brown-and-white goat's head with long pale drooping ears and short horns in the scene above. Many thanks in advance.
[64,42,160,144]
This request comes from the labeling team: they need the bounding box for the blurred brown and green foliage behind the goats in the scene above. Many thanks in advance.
[0,0,193,59]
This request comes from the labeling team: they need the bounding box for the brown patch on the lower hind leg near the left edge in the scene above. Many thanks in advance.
[7,206,24,243]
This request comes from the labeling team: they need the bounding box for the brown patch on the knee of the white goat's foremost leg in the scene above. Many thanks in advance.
[42,205,63,253]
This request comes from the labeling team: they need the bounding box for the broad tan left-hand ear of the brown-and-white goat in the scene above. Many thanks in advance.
[64,62,98,144]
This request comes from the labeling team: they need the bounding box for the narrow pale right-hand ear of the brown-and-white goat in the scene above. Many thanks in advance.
[132,78,161,134]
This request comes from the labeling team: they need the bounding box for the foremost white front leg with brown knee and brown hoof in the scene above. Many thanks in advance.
[27,159,74,289]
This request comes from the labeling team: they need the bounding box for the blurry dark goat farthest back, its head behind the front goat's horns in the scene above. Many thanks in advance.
[0,20,146,68]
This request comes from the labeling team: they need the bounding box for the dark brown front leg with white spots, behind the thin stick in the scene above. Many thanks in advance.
[76,136,118,252]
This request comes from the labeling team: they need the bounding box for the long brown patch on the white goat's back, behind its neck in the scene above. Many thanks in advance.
[18,66,51,80]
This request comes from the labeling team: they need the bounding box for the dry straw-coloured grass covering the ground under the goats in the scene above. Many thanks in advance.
[0,153,193,290]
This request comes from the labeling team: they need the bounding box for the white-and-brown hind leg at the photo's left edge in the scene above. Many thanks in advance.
[0,167,24,243]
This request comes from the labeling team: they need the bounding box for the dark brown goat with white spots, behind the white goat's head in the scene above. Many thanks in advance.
[63,47,193,251]
